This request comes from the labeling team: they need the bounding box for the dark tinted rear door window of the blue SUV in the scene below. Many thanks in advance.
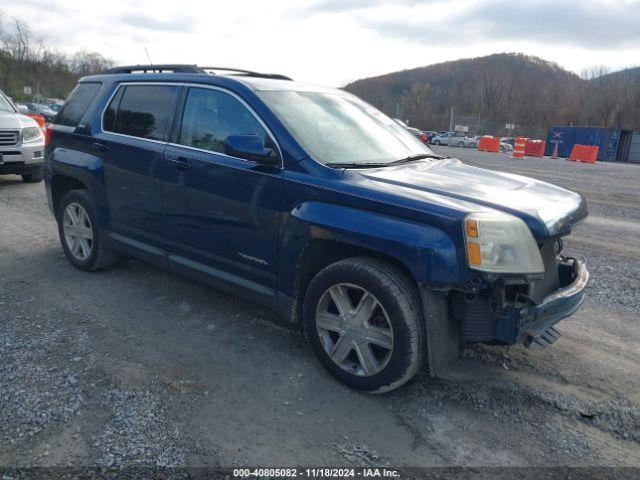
[104,85,178,140]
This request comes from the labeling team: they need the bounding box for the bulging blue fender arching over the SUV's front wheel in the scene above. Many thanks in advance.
[280,201,466,295]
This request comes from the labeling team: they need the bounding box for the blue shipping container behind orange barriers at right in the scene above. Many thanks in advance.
[545,127,620,162]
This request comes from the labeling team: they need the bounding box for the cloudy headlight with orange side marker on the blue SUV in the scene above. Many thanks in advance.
[464,213,544,273]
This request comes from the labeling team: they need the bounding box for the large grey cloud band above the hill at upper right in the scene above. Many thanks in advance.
[359,0,640,49]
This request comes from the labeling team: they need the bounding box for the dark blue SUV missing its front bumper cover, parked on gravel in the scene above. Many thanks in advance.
[45,65,589,392]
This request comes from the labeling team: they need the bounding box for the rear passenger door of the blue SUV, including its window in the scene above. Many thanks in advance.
[95,83,181,246]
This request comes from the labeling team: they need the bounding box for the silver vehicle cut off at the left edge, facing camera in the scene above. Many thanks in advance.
[0,91,44,182]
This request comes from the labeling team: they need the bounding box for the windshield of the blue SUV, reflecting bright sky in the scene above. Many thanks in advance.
[257,91,433,165]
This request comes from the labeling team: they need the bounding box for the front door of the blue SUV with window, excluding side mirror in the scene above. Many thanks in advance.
[162,87,282,295]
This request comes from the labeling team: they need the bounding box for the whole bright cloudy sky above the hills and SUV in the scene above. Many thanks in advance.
[0,0,640,86]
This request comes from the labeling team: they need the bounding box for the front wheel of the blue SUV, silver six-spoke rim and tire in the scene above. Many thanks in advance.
[303,257,426,393]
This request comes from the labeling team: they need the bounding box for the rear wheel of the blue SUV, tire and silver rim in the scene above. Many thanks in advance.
[56,190,118,272]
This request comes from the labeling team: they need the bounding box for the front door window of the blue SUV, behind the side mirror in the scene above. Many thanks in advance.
[179,88,269,153]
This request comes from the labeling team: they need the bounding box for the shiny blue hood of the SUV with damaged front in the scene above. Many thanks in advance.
[351,159,587,237]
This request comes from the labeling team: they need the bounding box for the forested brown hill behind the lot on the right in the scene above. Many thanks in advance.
[344,53,640,135]
